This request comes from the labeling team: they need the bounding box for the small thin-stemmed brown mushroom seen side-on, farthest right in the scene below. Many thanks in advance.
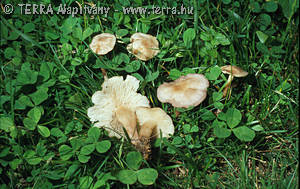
[221,65,248,97]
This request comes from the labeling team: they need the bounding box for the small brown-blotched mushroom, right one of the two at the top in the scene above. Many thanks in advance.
[127,33,159,61]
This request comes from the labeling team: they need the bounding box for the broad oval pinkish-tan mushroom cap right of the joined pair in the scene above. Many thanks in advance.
[157,74,209,108]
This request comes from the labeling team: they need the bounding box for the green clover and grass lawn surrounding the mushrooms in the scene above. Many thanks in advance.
[0,0,299,189]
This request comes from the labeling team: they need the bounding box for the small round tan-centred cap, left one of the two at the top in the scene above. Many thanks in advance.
[90,33,116,55]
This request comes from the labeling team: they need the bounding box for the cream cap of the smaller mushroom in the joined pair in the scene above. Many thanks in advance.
[136,107,174,138]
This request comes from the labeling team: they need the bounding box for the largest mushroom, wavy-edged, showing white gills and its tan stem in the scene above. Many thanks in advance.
[87,75,150,140]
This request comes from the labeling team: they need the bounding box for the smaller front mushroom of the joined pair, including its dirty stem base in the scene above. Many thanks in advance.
[133,107,174,159]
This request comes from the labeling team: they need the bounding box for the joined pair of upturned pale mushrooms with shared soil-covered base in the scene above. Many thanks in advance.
[87,75,174,158]
